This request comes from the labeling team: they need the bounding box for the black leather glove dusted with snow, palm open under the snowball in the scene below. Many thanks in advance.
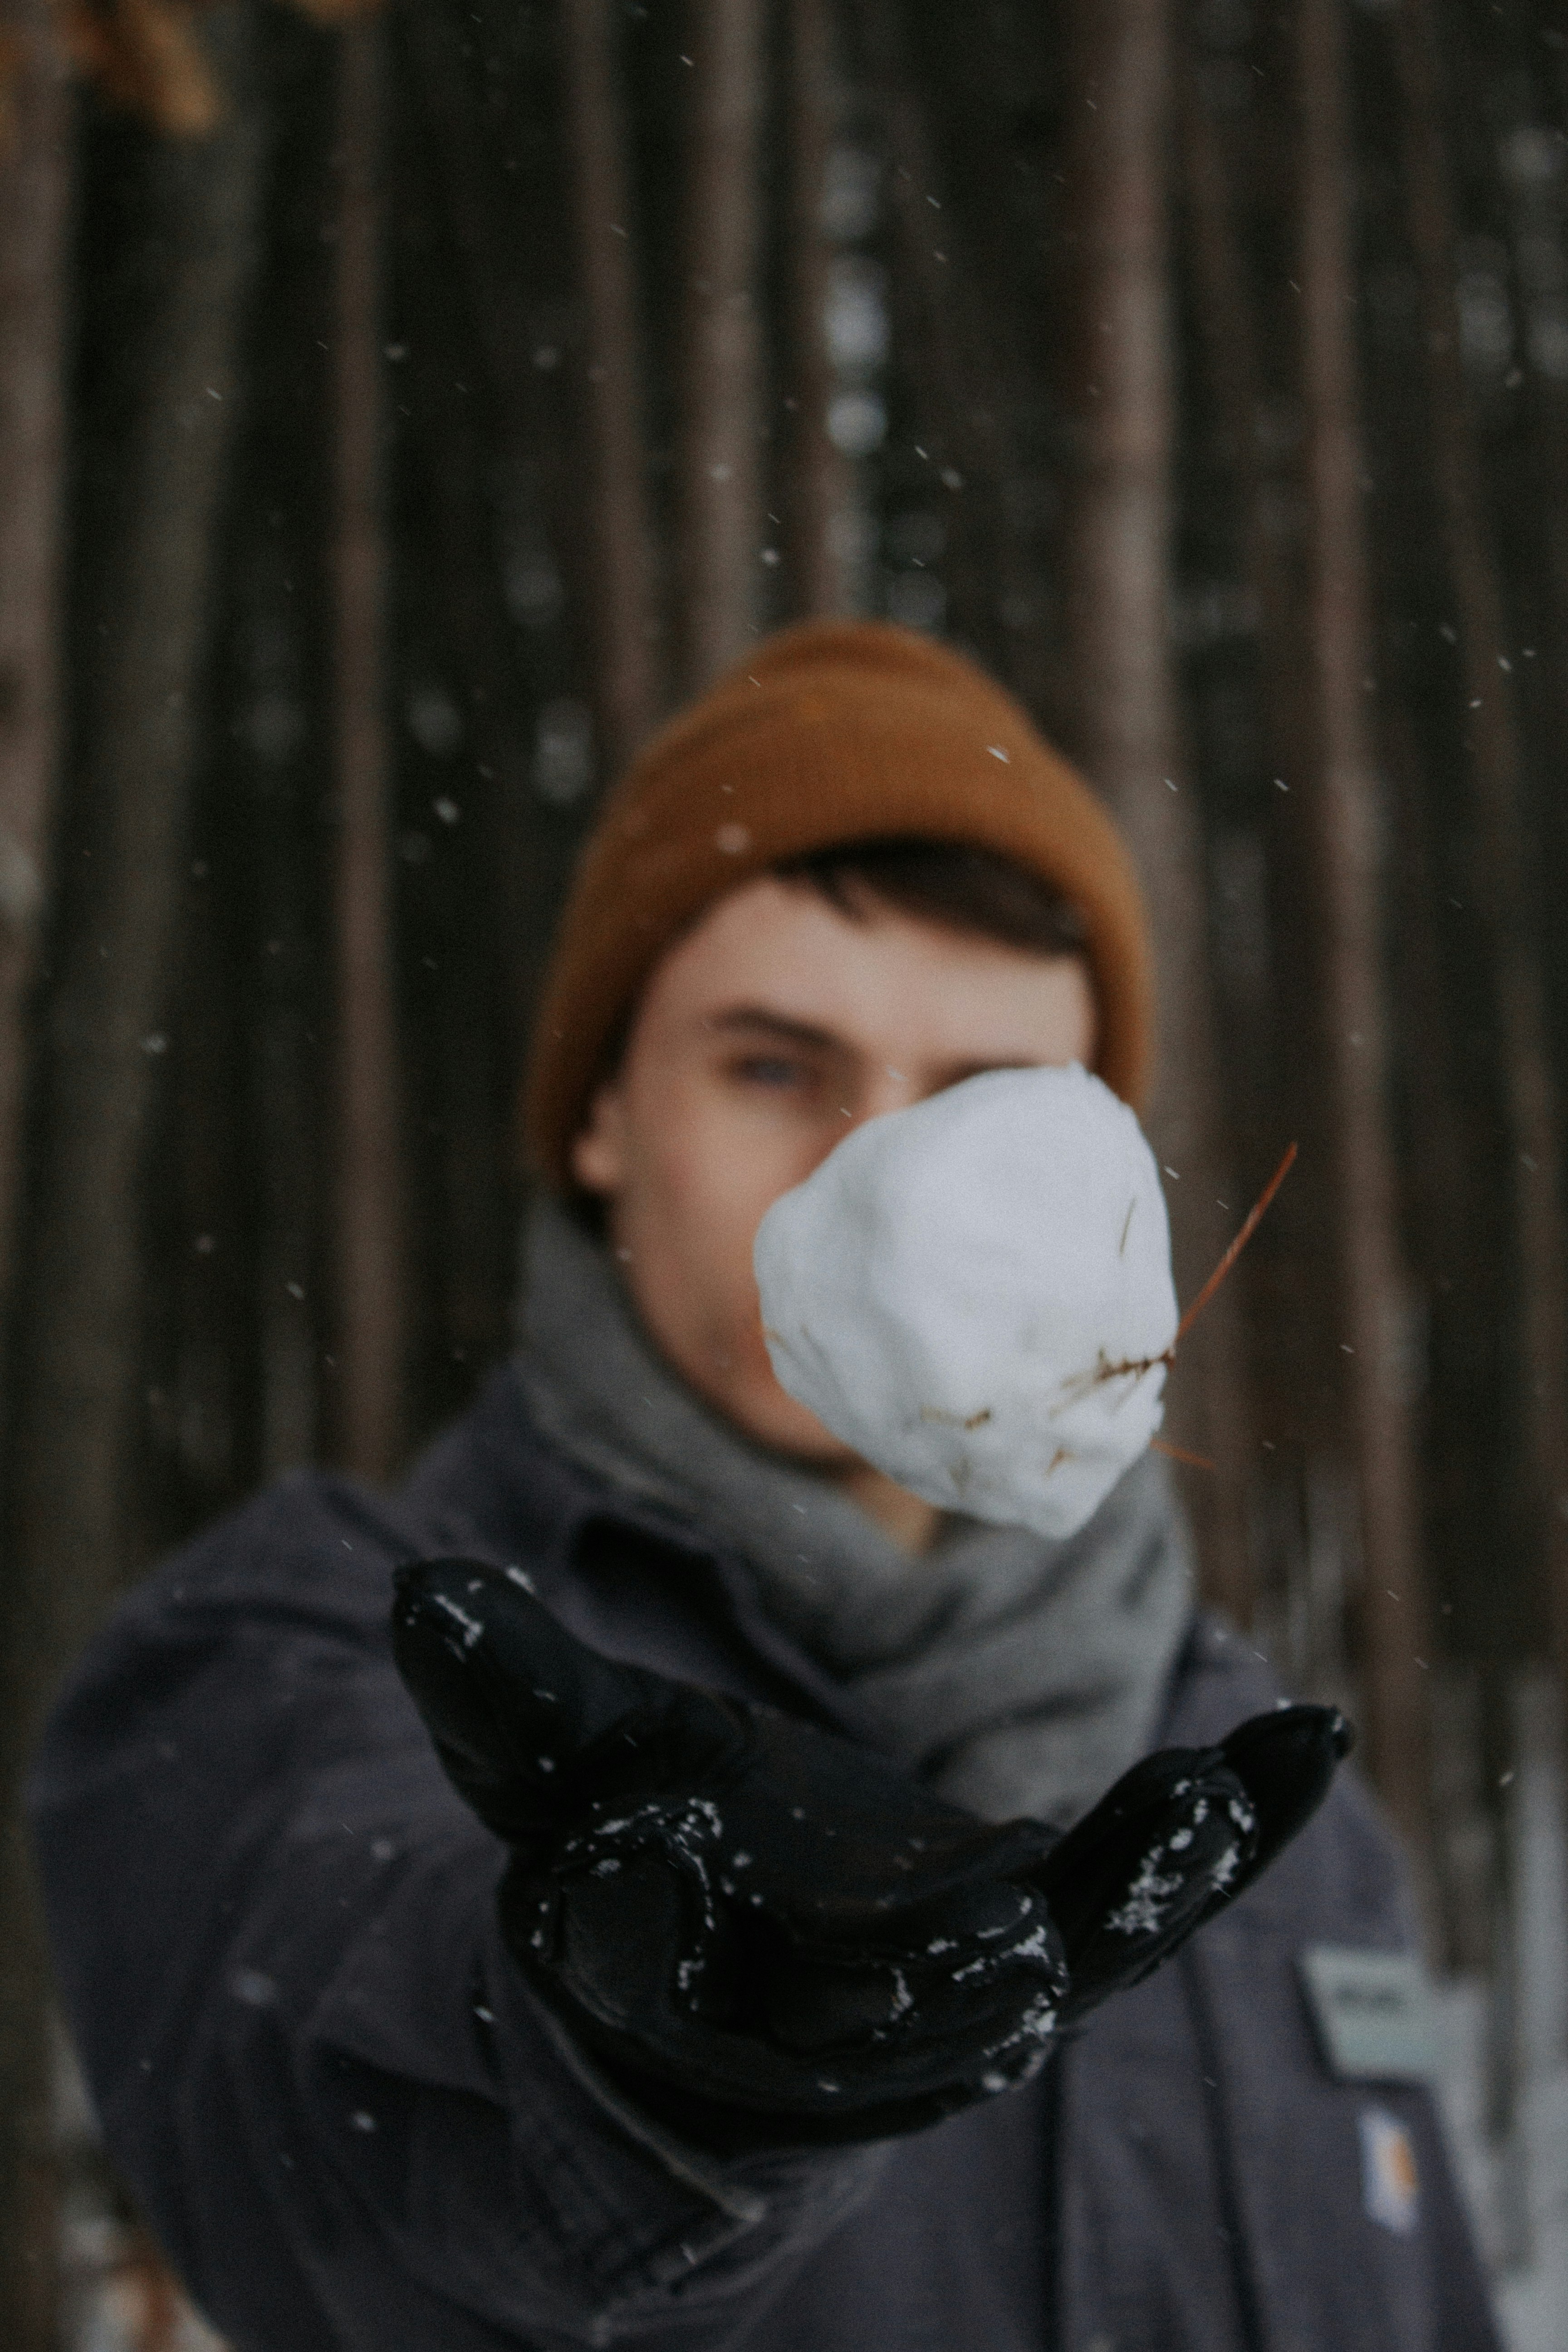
[392,1559,1338,2147]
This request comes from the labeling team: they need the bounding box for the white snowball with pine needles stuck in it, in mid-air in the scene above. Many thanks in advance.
[755,1063,1178,1536]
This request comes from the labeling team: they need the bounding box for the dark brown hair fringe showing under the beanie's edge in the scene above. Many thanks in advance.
[774,835,1088,955]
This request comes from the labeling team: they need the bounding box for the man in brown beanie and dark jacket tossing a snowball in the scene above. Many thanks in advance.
[33,626,1495,2352]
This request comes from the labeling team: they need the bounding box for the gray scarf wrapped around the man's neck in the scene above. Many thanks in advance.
[517,1200,1192,1823]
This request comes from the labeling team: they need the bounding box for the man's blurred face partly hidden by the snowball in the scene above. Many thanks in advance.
[571,877,1096,1470]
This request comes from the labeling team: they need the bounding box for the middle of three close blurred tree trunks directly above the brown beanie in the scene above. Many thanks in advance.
[679,0,764,694]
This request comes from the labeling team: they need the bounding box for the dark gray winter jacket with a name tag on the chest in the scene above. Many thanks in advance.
[33,1373,1495,2352]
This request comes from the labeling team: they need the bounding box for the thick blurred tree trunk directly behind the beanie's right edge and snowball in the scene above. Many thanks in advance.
[1065,0,1251,1618]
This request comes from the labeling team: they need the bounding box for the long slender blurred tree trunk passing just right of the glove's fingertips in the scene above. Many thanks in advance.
[1298,0,1431,1858]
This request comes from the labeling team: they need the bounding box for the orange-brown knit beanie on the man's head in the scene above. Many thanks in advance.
[524,621,1152,1188]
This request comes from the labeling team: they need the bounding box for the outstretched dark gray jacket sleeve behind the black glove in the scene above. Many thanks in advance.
[30,1480,882,2352]
